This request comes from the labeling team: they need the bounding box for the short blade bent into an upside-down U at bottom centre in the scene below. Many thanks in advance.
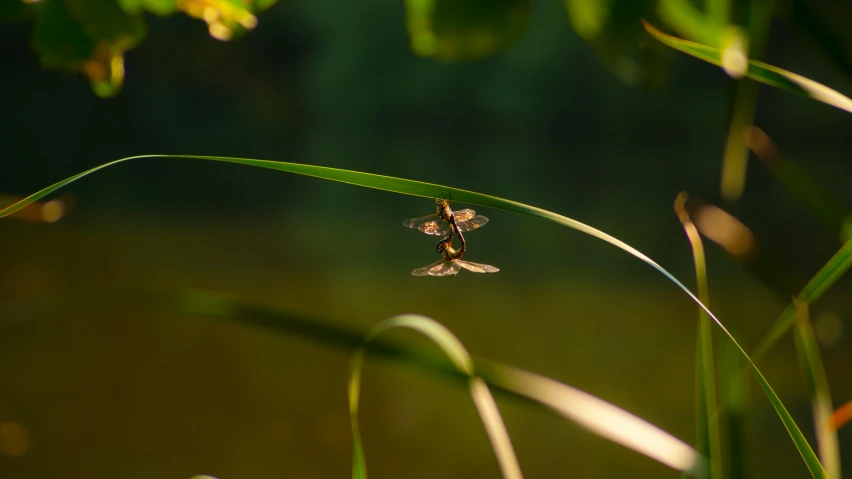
[349,315,523,479]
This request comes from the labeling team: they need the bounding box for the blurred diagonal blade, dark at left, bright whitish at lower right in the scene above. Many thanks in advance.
[179,291,702,476]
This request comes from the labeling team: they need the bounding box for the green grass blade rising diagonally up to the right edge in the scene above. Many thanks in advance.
[752,239,852,360]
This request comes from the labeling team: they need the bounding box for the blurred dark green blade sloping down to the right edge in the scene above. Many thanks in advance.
[744,127,852,241]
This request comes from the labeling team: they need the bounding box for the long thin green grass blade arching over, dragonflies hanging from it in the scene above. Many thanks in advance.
[0,155,825,477]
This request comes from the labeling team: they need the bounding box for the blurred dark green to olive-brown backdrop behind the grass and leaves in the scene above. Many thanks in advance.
[0,0,852,479]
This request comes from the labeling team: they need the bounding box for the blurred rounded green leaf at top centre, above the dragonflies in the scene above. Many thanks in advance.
[405,0,530,61]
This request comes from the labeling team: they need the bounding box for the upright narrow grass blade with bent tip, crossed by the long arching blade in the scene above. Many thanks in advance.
[674,193,722,477]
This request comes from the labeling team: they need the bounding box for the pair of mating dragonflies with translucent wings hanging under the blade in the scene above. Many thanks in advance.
[402,199,500,276]
